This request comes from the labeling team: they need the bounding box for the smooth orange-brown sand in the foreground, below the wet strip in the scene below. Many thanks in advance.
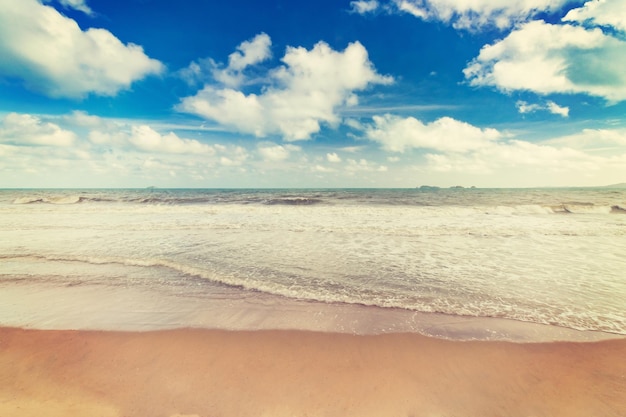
[0,328,626,417]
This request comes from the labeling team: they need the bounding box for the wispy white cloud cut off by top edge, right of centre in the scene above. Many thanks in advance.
[393,0,568,29]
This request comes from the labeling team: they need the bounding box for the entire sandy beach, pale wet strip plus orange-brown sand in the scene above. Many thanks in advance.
[0,281,626,417]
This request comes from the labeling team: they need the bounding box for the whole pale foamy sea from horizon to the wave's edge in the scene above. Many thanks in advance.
[0,188,626,334]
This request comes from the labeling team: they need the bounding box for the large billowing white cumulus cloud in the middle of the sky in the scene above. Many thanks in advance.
[177,36,393,141]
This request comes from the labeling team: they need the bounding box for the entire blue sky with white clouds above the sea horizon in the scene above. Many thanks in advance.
[0,0,626,188]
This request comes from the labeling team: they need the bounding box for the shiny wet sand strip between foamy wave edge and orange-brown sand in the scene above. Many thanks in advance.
[0,282,626,343]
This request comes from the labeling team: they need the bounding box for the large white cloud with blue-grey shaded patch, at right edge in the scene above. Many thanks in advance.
[463,21,626,102]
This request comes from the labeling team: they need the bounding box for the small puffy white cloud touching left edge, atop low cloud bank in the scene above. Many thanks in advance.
[0,113,76,146]
